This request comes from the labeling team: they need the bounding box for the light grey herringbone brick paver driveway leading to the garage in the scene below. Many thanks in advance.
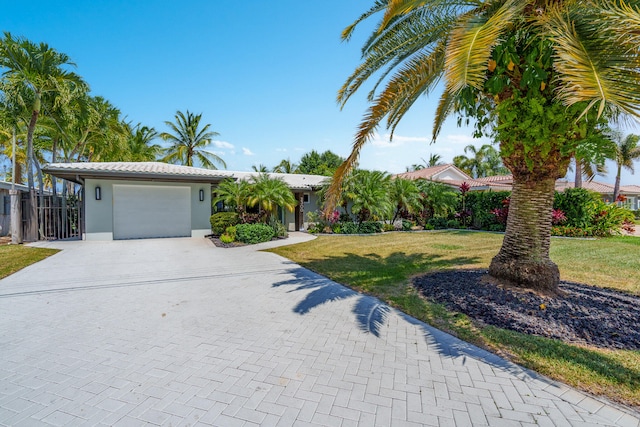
[0,235,639,426]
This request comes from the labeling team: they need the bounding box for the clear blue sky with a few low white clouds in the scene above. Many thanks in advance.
[0,0,640,185]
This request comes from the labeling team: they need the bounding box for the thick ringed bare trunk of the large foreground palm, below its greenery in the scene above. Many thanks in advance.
[489,177,560,292]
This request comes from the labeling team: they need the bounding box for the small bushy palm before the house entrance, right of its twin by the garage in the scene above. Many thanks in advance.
[247,173,298,223]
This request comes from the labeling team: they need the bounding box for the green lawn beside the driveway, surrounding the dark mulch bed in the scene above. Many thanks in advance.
[271,231,640,407]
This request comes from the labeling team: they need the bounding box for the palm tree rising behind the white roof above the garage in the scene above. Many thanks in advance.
[160,110,227,169]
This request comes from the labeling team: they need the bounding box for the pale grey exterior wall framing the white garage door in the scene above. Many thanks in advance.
[84,179,211,240]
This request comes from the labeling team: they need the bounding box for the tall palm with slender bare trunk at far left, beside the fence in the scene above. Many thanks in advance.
[0,32,87,241]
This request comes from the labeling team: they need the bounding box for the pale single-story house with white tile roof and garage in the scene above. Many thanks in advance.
[43,162,326,240]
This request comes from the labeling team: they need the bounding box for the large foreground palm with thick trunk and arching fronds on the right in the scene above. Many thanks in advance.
[329,0,640,291]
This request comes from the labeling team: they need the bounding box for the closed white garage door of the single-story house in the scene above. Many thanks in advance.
[113,185,191,239]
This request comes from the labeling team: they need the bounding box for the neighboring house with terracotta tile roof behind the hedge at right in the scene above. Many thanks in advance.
[394,164,640,210]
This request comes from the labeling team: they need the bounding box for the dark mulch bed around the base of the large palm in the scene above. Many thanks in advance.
[413,270,640,350]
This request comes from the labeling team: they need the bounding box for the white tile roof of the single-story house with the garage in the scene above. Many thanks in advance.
[42,162,327,190]
